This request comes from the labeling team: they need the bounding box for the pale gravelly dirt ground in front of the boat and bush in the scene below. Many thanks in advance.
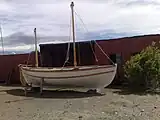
[0,86,160,120]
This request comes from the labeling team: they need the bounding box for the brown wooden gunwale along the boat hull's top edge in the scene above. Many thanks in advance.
[19,64,117,72]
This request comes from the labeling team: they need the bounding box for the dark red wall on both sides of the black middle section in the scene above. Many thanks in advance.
[0,35,160,83]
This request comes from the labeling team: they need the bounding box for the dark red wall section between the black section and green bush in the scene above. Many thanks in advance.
[95,35,160,82]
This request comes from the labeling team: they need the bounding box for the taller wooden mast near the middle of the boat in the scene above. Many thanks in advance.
[70,2,77,68]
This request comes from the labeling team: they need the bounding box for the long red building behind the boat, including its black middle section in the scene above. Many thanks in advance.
[0,35,160,83]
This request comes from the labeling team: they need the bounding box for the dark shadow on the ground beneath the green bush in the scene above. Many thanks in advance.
[108,85,160,95]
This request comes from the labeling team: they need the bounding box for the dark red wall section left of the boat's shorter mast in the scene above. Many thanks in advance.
[0,54,34,84]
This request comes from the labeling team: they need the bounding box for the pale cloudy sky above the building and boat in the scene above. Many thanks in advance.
[0,0,160,52]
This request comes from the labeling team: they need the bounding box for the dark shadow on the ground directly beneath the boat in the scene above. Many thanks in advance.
[6,89,102,99]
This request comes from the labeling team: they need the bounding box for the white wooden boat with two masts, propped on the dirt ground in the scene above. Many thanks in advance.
[19,2,117,94]
